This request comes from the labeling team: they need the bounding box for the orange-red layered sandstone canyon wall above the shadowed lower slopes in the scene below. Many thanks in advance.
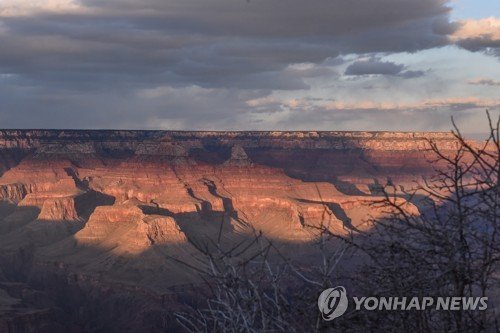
[0,130,464,249]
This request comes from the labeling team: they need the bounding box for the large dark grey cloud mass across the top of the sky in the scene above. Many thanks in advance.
[0,0,450,91]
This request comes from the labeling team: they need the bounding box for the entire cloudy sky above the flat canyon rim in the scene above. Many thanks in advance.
[0,0,500,133]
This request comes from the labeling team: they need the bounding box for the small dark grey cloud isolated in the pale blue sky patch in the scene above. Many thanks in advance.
[344,58,424,79]
